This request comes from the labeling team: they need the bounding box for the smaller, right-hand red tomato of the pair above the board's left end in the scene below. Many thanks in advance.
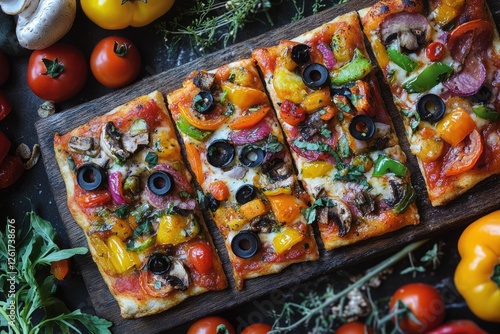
[90,36,141,88]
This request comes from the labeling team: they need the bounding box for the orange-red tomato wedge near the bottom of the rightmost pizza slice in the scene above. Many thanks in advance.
[443,129,483,176]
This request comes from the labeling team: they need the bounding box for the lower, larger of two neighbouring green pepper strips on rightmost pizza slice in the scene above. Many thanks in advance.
[403,62,453,93]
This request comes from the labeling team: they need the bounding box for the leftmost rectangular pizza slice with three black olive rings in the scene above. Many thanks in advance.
[54,91,227,318]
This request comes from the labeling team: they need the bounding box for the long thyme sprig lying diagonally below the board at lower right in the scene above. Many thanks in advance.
[269,240,427,334]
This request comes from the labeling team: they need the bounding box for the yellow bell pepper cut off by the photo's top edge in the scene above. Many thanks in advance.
[80,0,175,30]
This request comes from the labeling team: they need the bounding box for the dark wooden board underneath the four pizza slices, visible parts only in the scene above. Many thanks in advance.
[35,0,500,333]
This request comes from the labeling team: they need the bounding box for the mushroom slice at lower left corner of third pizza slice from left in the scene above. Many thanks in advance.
[316,197,352,237]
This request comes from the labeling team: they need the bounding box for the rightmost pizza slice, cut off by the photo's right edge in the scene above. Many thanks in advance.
[359,0,500,206]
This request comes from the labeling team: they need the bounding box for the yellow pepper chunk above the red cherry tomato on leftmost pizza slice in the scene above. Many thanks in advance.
[156,214,200,245]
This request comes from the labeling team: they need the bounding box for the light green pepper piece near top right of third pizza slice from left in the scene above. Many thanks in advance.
[330,49,373,86]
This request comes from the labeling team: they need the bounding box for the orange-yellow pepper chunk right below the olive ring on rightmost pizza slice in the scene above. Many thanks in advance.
[436,108,476,146]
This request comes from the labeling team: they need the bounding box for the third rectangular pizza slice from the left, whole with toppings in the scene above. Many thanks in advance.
[253,12,419,250]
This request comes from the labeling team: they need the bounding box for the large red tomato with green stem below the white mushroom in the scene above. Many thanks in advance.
[27,43,87,102]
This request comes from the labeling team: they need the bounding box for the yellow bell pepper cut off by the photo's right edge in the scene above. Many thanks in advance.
[455,210,500,322]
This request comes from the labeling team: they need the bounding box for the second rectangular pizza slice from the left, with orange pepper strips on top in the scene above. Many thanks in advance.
[167,59,318,289]
